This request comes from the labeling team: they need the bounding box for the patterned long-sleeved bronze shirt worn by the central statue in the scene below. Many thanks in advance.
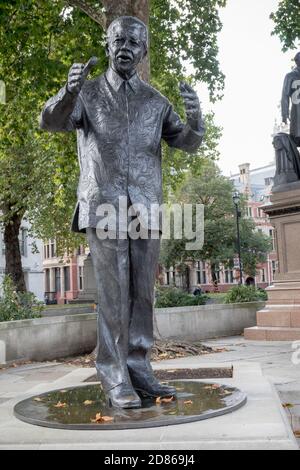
[41,68,205,232]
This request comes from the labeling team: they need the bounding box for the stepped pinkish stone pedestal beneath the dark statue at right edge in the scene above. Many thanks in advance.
[245,182,300,341]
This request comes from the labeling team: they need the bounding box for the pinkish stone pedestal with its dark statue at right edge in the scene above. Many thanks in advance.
[245,53,300,341]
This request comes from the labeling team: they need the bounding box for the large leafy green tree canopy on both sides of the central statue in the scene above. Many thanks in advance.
[0,0,225,253]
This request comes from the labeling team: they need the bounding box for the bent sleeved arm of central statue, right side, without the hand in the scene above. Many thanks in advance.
[162,103,205,153]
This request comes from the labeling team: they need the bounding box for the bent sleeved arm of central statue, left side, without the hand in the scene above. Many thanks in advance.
[40,86,83,132]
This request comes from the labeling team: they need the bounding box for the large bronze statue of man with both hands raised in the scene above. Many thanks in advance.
[41,17,204,408]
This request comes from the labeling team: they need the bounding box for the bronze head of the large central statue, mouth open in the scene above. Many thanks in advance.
[106,16,148,76]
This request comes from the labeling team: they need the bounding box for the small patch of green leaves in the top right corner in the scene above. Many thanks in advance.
[271,0,300,51]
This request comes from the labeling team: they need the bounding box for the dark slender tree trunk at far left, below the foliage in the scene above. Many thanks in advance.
[4,214,26,292]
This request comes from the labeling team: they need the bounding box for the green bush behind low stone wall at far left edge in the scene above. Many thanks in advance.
[0,276,44,322]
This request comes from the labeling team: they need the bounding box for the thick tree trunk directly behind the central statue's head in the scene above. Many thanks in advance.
[102,0,150,82]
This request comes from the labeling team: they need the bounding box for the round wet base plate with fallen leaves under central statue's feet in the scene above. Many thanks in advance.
[14,380,247,430]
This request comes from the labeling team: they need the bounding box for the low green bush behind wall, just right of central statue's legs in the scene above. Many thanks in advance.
[155,287,207,308]
